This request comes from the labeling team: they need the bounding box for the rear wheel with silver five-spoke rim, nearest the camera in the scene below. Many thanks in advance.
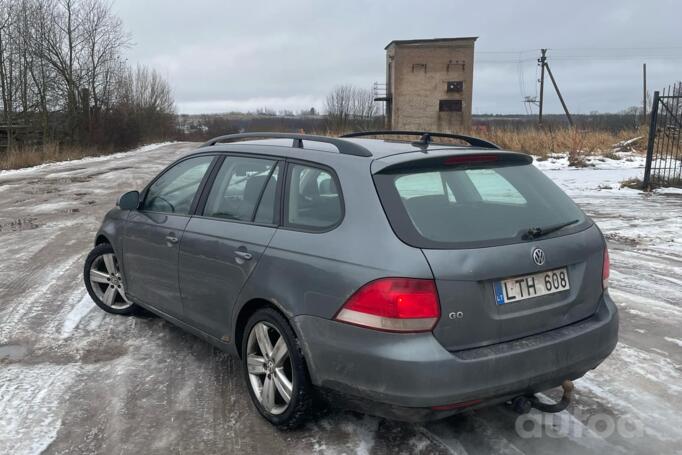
[241,308,314,430]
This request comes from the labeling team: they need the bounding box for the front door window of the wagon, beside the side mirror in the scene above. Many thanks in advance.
[142,156,213,215]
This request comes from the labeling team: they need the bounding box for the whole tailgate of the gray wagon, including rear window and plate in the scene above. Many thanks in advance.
[374,150,604,350]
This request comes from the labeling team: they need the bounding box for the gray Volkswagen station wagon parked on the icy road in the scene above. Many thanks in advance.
[85,131,618,428]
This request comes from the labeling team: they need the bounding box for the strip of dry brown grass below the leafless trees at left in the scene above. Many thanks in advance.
[0,143,113,170]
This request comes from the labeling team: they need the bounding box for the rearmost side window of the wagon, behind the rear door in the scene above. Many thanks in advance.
[286,164,343,230]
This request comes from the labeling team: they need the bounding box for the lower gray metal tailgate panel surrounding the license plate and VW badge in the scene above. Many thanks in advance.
[423,225,604,350]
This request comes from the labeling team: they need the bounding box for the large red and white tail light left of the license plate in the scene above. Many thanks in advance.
[335,278,440,332]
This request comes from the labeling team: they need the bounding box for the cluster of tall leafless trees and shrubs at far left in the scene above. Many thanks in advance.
[0,0,175,151]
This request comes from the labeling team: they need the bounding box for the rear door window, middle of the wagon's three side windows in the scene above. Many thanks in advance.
[204,156,276,223]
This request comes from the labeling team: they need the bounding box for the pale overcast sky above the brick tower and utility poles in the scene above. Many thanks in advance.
[113,0,682,114]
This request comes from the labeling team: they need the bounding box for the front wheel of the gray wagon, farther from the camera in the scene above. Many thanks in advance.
[83,243,138,315]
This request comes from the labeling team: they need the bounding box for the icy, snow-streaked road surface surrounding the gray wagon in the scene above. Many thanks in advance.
[0,144,682,454]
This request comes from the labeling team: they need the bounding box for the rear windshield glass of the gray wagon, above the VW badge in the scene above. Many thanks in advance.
[374,164,591,248]
